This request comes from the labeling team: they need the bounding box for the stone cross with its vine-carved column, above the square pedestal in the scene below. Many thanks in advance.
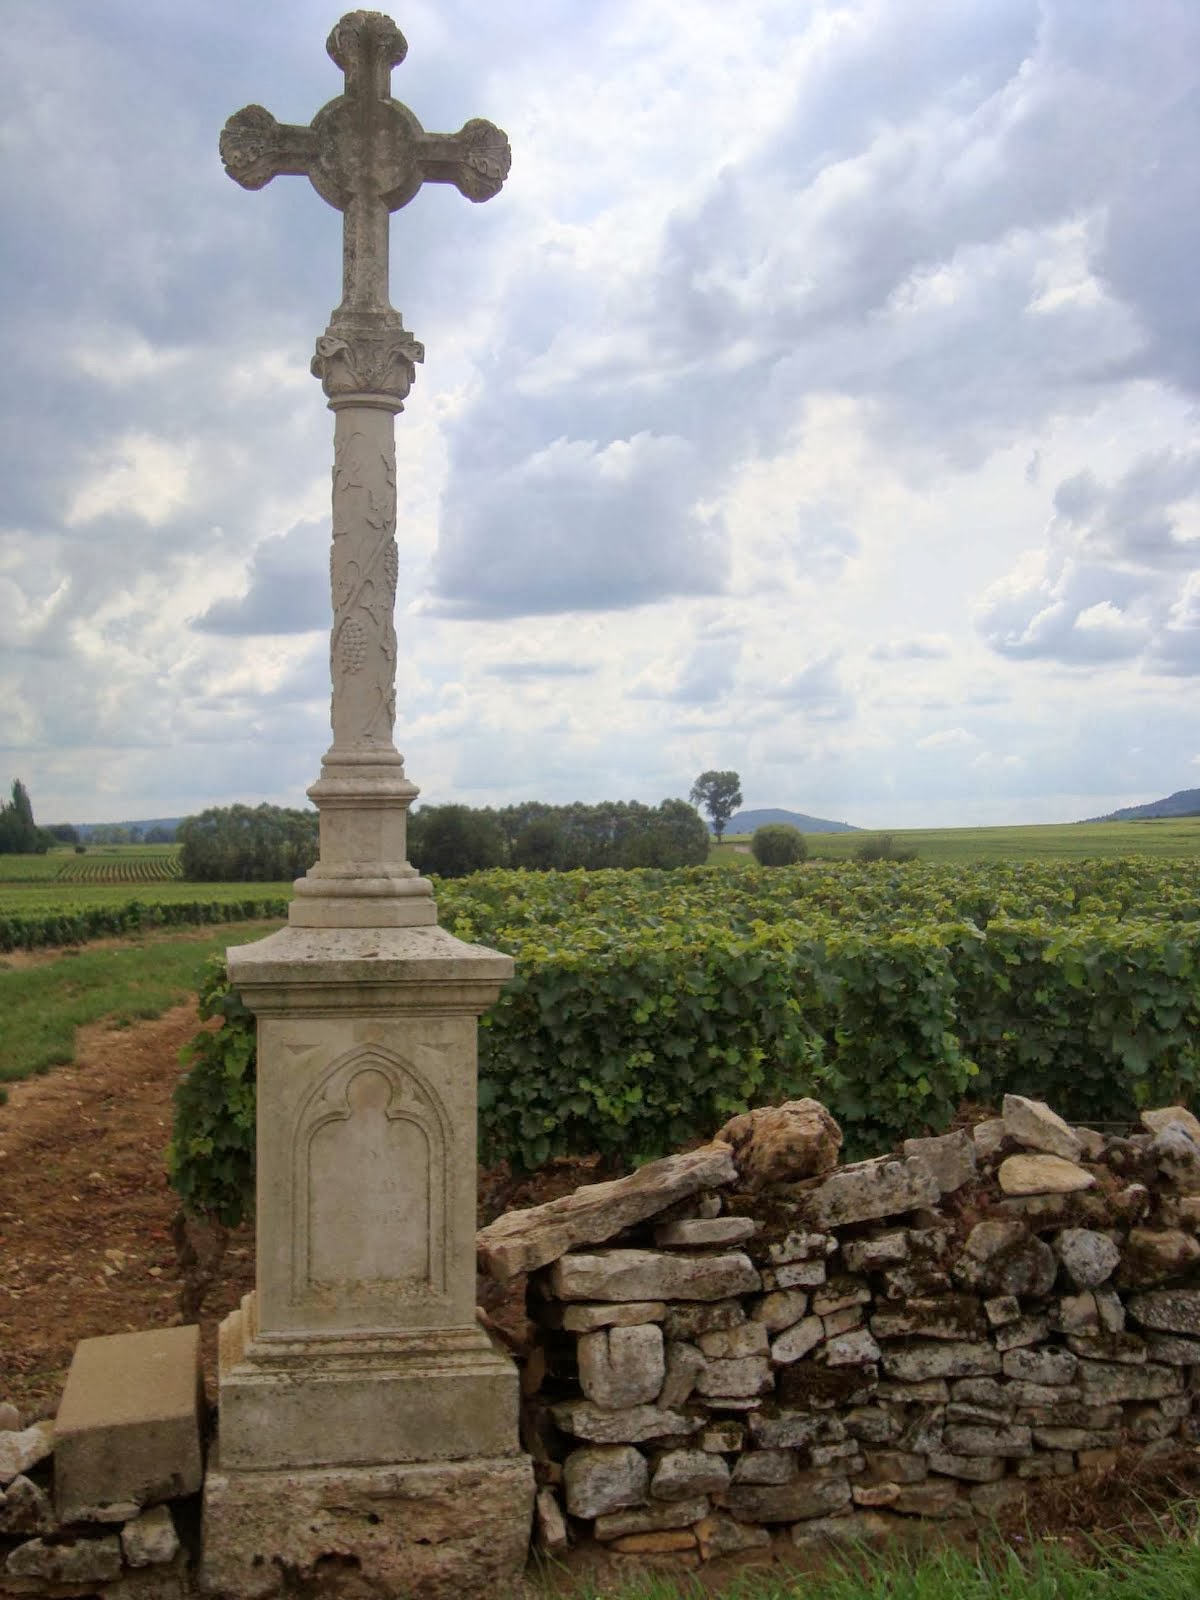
[221,11,510,926]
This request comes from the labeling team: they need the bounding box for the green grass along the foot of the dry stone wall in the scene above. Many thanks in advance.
[555,1518,1200,1600]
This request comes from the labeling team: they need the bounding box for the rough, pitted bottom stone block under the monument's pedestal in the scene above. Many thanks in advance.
[200,1456,533,1600]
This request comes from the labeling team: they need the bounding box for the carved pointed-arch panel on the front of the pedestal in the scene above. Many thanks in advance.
[293,1045,451,1307]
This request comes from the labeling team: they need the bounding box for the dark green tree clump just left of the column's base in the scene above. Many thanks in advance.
[178,805,318,883]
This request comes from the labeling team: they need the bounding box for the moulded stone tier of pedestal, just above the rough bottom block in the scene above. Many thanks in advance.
[219,1294,520,1472]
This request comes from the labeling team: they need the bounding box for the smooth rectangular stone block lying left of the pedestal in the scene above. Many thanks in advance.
[54,1325,203,1522]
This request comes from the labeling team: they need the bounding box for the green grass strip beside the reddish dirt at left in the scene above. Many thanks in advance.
[0,922,278,1083]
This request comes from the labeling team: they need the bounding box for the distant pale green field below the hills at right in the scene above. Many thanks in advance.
[709,816,1200,867]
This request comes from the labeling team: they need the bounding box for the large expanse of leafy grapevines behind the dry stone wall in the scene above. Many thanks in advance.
[167,861,1200,1222]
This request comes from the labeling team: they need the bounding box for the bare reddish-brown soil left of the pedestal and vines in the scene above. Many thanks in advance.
[0,1000,253,1419]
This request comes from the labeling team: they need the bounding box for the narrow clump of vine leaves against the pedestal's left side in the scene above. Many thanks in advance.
[166,957,256,1227]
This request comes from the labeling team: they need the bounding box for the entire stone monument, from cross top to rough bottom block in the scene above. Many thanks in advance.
[202,11,533,1600]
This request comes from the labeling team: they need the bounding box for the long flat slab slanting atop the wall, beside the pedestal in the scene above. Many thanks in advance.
[475,1142,738,1280]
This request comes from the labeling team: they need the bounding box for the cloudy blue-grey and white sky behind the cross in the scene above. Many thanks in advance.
[0,0,1200,827]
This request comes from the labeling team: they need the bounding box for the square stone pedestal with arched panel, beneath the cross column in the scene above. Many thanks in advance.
[202,926,533,1600]
